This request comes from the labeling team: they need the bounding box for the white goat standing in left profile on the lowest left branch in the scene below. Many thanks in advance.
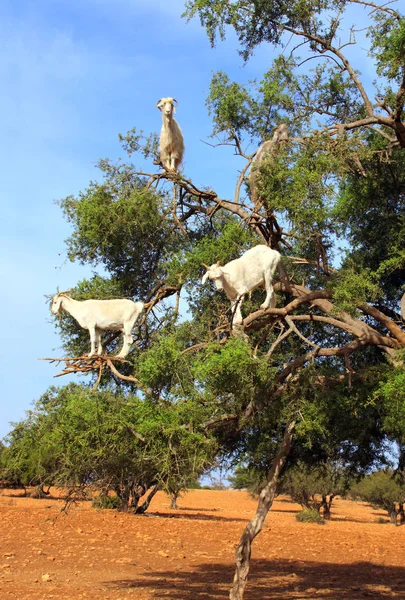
[51,292,144,358]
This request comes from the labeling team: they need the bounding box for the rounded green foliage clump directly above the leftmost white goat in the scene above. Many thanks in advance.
[60,181,172,297]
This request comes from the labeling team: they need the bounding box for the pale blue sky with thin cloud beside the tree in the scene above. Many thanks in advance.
[0,0,376,438]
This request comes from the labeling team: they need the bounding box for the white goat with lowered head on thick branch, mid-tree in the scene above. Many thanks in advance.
[201,245,281,325]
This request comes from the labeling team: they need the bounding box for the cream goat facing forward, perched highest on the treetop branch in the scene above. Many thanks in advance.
[156,98,184,171]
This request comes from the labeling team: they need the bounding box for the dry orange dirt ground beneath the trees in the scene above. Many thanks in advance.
[0,490,405,600]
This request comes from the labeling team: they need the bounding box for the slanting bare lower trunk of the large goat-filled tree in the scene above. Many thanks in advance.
[229,421,295,600]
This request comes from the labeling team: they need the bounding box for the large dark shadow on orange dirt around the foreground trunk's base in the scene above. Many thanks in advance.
[106,560,405,600]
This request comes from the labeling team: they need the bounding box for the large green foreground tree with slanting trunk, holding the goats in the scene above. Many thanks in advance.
[45,0,405,600]
